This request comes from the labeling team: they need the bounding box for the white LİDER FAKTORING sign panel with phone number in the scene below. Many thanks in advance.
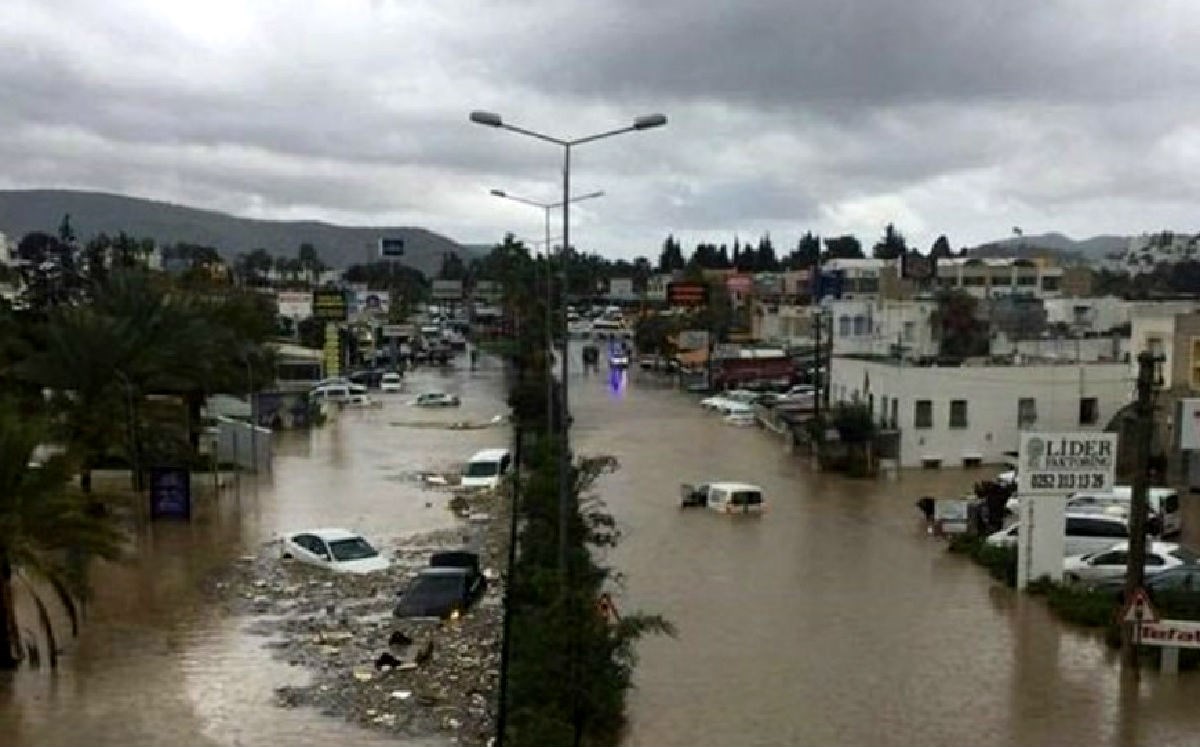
[1016,431,1117,495]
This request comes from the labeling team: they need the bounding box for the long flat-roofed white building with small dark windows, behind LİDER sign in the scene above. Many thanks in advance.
[830,357,1133,467]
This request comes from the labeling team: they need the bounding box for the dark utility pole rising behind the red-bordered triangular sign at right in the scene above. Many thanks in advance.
[1121,351,1159,669]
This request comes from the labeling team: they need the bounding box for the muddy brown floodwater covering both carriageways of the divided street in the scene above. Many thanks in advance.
[7,343,1200,746]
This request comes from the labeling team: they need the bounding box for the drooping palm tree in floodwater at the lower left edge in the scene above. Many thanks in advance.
[0,398,121,669]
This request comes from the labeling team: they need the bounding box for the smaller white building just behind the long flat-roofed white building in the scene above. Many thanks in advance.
[823,300,938,359]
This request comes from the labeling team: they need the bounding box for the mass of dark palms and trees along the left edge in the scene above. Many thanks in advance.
[0,220,275,669]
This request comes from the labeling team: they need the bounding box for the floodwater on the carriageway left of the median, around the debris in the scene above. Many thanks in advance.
[0,361,510,747]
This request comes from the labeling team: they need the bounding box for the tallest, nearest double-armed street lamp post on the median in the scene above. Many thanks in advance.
[470,110,667,588]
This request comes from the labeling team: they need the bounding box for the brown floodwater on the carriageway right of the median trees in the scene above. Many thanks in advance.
[571,355,1200,747]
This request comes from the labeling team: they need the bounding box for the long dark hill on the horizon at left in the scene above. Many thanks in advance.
[0,190,476,275]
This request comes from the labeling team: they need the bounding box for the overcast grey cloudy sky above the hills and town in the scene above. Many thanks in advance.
[0,0,1200,257]
